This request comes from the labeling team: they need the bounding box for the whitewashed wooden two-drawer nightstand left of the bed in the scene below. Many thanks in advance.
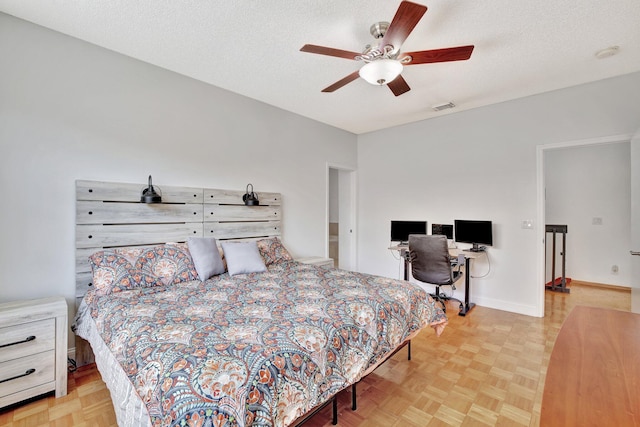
[0,297,68,408]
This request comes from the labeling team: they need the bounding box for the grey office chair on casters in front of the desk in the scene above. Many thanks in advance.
[409,234,464,312]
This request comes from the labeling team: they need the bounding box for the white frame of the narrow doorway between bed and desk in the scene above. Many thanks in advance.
[324,162,358,271]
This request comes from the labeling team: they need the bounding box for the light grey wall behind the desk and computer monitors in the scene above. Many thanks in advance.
[358,73,640,315]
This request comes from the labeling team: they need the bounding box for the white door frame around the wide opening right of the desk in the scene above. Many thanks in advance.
[536,134,633,317]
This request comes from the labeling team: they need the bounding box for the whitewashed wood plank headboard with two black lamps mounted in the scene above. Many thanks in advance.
[76,180,282,365]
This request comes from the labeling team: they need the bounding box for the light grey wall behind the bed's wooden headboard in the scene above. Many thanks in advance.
[0,13,357,340]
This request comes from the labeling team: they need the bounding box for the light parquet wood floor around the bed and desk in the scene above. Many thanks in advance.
[0,281,631,427]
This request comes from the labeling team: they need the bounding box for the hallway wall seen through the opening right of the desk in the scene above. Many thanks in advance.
[544,142,631,287]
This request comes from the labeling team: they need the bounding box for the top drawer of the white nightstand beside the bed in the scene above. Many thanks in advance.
[0,318,56,364]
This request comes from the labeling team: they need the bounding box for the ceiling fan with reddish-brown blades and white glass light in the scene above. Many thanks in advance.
[300,1,473,96]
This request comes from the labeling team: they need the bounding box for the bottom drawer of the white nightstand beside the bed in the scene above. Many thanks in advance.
[0,350,56,399]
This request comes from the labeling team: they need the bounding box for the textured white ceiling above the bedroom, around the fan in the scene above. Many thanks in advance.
[0,0,640,134]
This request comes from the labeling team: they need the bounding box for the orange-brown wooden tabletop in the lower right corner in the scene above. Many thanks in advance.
[540,306,640,427]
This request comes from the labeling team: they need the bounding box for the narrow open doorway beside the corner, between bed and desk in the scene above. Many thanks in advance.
[326,165,357,271]
